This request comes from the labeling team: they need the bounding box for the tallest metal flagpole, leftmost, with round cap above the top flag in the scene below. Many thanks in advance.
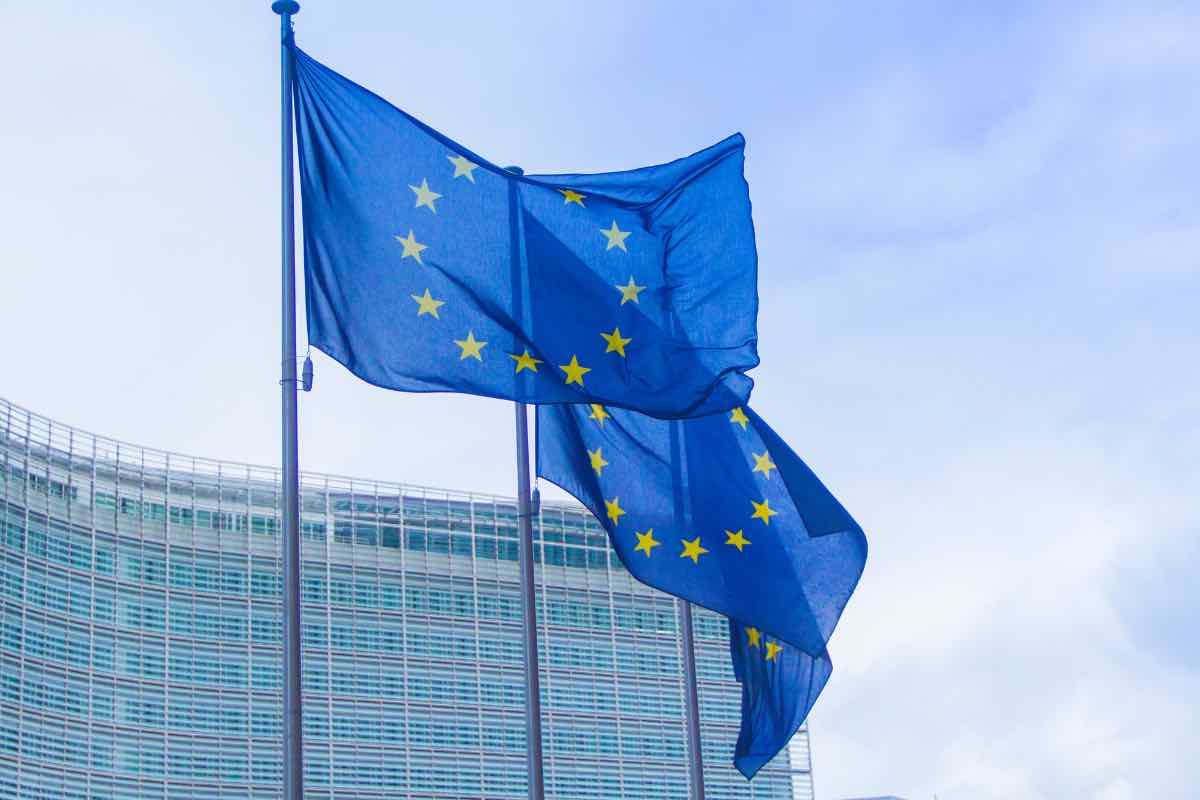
[271,0,304,800]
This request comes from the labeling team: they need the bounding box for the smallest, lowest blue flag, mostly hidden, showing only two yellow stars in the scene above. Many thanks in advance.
[730,620,833,778]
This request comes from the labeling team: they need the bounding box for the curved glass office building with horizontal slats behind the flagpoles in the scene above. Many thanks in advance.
[0,401,812,800]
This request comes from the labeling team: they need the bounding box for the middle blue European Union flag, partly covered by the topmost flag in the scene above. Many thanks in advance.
[538,404,866,656]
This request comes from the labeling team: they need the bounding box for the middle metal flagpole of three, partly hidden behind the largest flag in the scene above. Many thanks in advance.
[505,167,546,800]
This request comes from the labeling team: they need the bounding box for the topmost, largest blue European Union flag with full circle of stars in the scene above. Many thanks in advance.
[294,48,758,417]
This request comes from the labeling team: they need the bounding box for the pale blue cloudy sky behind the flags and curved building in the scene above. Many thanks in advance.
[0,0,1200,800]
